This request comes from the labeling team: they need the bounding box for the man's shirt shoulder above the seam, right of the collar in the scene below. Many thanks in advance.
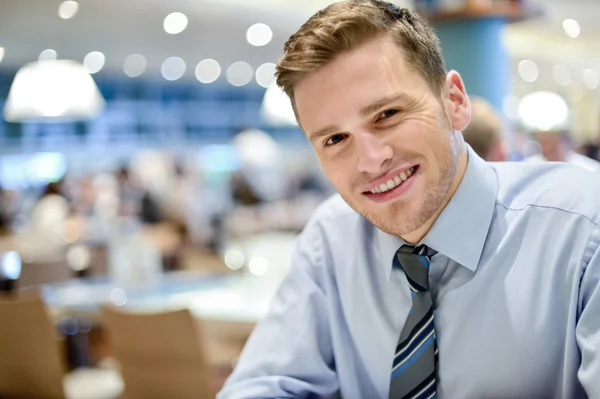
[491,162,600,224]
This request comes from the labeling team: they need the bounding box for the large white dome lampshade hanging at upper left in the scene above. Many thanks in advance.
[4,60,105,122]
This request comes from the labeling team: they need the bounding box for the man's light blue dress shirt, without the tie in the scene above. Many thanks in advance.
[218,149,600,399]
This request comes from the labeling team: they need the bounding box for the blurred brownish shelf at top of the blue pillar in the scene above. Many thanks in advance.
[417,0,543,23]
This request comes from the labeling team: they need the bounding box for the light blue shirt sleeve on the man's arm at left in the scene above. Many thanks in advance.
[217,225,338,399]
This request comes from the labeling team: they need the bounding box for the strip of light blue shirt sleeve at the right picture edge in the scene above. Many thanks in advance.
[575,227,600,398]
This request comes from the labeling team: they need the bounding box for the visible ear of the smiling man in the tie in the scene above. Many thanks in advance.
[444,71,471,131]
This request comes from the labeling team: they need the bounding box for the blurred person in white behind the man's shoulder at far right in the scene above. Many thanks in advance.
[525,130,600,171]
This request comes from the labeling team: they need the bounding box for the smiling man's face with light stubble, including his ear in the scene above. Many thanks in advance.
[294,38,470,236]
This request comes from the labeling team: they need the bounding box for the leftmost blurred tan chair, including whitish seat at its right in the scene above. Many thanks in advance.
[0,292,122,399]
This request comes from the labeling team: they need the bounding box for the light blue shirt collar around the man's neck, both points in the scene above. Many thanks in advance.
[375,145,498,276]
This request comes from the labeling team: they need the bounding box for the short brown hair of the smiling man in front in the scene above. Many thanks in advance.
[275,0,446,103]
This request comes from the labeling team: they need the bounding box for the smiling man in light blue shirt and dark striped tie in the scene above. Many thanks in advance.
[219,0,600,399]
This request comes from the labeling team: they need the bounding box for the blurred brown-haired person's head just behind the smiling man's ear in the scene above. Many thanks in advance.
[462,98,508,162]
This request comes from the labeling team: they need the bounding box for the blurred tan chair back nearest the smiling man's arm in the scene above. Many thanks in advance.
[103,307,216,399]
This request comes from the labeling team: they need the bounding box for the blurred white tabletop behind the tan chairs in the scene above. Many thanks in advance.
[41,272,277,324]
